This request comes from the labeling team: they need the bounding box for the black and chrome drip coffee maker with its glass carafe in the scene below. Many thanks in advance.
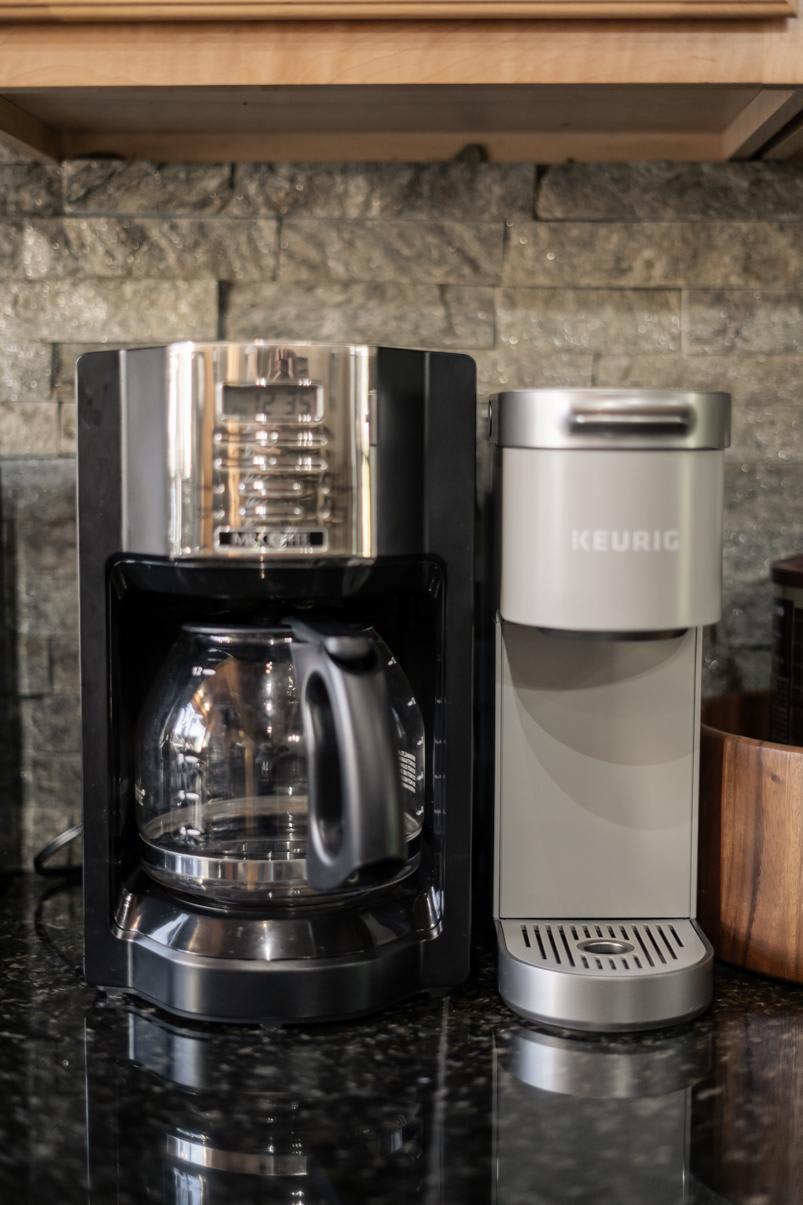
[77,342,475,1021]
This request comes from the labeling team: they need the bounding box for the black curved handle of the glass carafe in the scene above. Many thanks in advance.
[289,619,405,892]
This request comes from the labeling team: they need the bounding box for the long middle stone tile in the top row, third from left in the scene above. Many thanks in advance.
[230,163,535,222]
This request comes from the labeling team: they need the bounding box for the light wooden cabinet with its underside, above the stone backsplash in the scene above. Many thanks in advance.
[0,12,803,163]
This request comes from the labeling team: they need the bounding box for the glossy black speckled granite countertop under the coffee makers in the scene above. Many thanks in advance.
[0,875,803,1205]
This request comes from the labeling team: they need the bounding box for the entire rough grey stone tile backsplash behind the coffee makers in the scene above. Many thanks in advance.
[0,160,803,865]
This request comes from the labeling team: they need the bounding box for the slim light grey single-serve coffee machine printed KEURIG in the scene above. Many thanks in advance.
[491,389,729,1030]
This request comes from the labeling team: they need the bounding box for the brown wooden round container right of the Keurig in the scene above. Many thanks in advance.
[698,692,803,983]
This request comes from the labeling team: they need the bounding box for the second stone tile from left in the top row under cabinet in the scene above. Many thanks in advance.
[63,159,233,217]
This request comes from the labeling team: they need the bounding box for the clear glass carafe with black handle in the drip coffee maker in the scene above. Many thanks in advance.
[135,622,424,904]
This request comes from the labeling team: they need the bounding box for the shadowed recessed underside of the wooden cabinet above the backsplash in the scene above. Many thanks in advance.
[0,84,803,163]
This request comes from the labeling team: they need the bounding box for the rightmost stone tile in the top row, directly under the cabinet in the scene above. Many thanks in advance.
[535,163,803,222]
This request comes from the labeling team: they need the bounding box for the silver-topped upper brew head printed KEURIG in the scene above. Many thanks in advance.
[492,389,729,633]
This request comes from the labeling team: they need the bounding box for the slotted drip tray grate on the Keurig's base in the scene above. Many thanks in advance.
[500,919,707,977]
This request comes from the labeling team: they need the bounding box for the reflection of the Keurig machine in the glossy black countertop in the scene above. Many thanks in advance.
[490,1025,720,1205]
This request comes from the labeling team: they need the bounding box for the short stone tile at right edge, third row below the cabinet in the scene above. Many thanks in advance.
[684,289,803,355]
